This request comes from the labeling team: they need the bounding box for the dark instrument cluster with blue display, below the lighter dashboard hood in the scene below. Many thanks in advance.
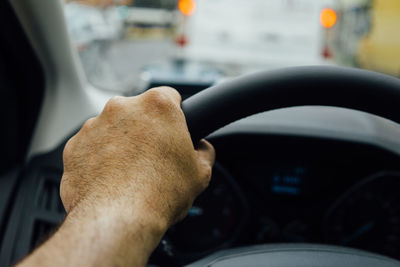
[151,134,400,264]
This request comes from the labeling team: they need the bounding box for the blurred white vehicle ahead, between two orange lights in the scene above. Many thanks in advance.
[183,0,334,75]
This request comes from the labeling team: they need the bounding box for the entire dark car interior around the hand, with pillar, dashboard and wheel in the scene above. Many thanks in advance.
[0,0,400,267]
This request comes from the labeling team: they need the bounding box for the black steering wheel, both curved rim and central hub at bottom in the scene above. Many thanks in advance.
[182,66,400,267]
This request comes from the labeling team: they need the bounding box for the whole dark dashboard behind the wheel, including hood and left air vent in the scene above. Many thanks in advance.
[0,107,400,266]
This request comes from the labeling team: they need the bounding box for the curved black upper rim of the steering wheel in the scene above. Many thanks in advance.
[182,66,400,143]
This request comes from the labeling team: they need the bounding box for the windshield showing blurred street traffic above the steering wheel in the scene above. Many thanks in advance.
[64,0,400,93]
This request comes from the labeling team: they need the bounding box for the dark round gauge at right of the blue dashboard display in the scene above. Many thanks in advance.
[324,173,400,258]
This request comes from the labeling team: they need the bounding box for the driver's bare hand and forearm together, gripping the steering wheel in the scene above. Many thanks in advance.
[18,87,215,267]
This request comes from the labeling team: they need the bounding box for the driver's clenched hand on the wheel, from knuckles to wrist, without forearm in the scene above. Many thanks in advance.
[61,87,214,225]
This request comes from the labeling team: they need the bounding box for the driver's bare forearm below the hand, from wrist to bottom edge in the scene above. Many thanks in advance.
[18,200,167,267]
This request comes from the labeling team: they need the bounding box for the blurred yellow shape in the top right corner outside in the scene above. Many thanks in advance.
[357,0,400,76]
